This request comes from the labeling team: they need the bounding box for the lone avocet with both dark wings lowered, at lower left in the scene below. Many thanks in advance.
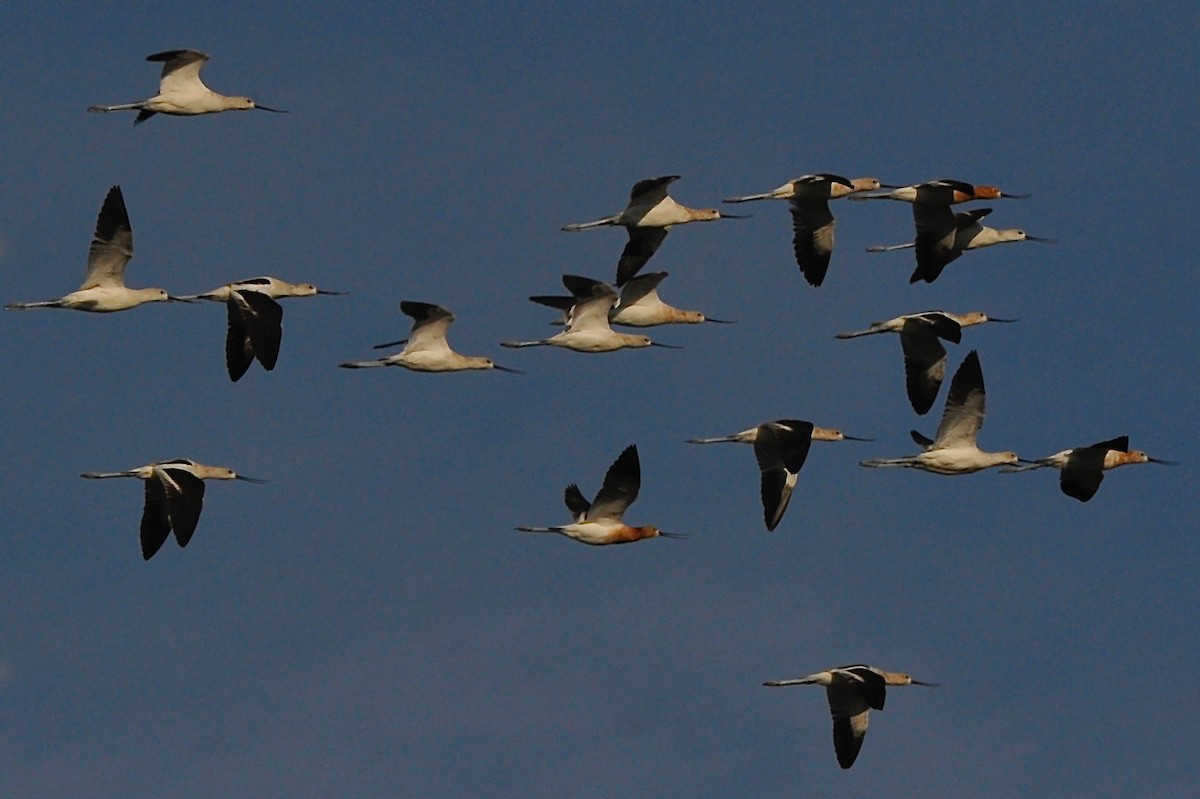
[83,458,266,560]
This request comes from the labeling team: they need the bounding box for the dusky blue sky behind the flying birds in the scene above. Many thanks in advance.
[0,2,1200,798]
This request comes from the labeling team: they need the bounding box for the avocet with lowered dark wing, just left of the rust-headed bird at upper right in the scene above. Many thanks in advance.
[724,174,881,286]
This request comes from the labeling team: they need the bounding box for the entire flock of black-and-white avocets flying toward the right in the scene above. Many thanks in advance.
[5,50,1170,769]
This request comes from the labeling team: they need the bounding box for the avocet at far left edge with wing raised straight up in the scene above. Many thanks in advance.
[5,186,186,313]
